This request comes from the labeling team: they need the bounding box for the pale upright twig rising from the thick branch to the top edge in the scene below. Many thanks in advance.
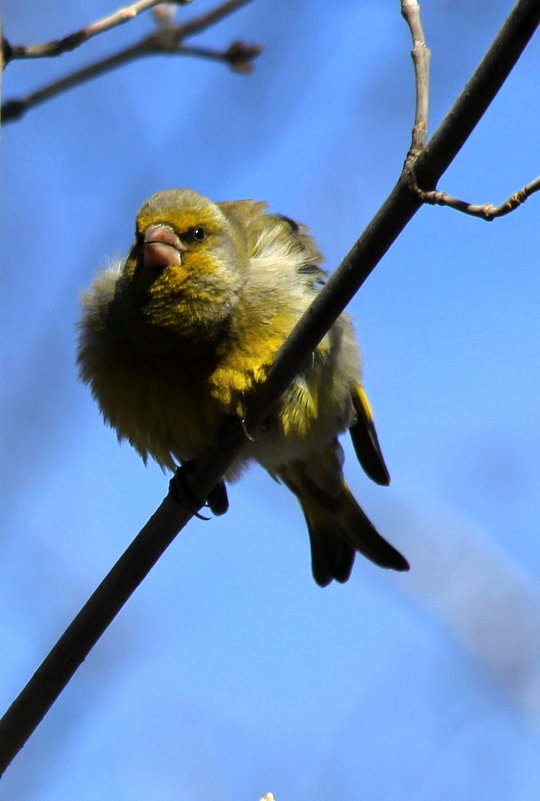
[401,0,431,167]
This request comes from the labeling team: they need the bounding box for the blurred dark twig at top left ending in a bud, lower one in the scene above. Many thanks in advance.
[2,0,262,122]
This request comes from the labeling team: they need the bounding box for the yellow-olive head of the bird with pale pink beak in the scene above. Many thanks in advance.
[119,189,248,339]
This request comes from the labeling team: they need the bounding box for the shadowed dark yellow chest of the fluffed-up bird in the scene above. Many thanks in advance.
[94,332,250,467]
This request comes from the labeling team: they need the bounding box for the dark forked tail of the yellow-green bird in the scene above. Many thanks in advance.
[279,462,409,587]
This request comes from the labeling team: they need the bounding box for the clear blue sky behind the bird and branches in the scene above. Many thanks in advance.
[0,0,540,801]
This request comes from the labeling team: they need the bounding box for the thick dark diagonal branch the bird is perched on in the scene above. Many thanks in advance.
[0,0,540,771]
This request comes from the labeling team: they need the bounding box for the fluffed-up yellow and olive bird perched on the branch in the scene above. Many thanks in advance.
[77,188,409,587]
